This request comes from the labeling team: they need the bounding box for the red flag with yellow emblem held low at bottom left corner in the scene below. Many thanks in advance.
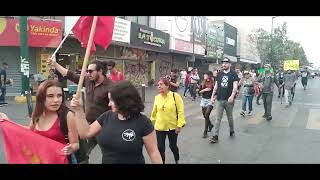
[0,120,68,164]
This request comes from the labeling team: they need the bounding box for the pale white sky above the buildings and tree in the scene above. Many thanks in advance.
[208,16,320,67]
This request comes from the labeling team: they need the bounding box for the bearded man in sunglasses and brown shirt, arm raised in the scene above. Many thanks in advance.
[48,58,112,164]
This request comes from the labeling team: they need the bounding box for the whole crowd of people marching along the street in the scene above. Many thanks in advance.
[0,58,309,164]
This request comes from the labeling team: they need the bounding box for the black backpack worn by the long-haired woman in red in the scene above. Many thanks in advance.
[59,110,88,164]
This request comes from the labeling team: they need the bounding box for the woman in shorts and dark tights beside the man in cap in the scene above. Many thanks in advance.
[199,71,215,138]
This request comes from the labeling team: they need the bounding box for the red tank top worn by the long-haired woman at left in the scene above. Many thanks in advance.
[33,117,67,144]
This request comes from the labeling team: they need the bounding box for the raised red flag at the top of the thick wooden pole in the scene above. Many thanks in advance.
[72,16,115,53]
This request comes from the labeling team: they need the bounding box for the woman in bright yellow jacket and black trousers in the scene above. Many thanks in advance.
[150,78,186,164]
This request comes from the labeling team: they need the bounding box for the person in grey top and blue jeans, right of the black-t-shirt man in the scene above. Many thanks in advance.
[239,71,255,117]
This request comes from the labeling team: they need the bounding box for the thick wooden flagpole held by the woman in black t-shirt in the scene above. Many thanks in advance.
[76,16,98,99]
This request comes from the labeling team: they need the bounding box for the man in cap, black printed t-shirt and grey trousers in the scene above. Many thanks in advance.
[210,57,239,143]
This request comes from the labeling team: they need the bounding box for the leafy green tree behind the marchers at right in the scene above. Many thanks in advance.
[250,23,309,68]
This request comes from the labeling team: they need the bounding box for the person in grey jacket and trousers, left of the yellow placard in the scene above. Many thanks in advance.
[257,64,279,121]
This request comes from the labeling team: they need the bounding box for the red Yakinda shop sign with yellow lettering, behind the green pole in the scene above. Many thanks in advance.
[0,18,62,48]
